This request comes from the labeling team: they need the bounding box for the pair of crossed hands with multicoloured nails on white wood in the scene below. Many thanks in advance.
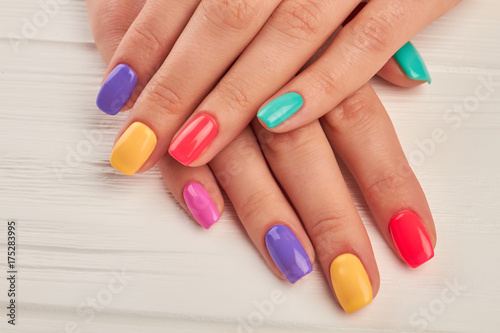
[87,0,458,312]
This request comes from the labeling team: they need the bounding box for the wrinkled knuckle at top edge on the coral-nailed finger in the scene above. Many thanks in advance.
[271,0,323,40]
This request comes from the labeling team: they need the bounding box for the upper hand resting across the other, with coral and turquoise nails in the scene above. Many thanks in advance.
[89,0,459,174]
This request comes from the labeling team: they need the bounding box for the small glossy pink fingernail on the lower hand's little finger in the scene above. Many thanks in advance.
[182,183,220,229]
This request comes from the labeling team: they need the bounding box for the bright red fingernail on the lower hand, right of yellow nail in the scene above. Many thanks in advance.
[389,210,434,268]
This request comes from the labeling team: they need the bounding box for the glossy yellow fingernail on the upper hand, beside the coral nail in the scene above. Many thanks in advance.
[110,122,156,175]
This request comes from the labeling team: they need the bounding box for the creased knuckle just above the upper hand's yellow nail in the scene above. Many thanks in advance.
[146,78,184,114]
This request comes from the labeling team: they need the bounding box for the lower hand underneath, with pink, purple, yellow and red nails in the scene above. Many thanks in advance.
[90,0,436,312]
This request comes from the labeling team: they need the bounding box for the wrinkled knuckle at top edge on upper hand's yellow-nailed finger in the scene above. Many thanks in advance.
[202,0,261,30]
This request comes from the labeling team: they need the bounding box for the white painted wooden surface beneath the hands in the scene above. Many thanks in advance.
[0,0,500,333]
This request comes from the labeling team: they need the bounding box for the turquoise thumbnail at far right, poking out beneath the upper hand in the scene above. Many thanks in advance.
[394,42,431,83]
